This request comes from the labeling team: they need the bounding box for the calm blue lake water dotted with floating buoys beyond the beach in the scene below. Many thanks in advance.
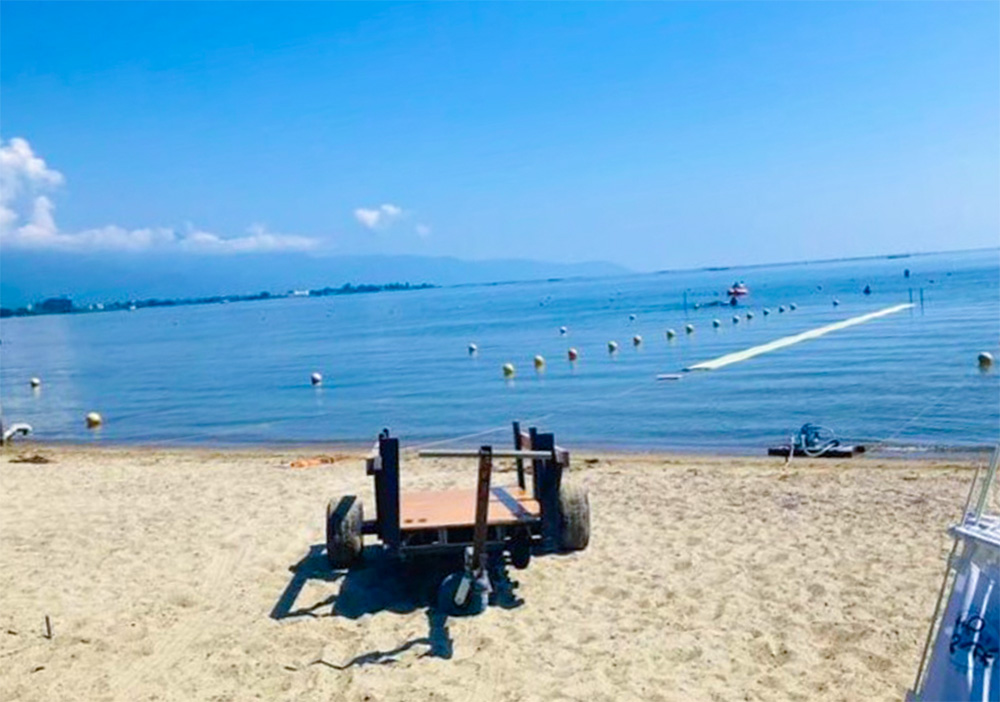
[0,251,1000,452]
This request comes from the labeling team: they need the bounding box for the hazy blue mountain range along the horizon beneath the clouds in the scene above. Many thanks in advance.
[0,251,630,308]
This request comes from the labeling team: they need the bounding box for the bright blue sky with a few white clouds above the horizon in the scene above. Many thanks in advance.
[0,2,1000,270]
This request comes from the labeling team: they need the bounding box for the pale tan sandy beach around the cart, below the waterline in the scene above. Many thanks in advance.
[0,444,984,702]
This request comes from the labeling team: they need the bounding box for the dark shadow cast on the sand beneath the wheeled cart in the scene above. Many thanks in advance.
[270,544,524,670]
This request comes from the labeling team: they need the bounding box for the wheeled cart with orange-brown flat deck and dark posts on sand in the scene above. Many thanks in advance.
[326,422,590,614]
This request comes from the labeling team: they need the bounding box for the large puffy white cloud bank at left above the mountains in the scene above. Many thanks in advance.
[0,138,320,254]
